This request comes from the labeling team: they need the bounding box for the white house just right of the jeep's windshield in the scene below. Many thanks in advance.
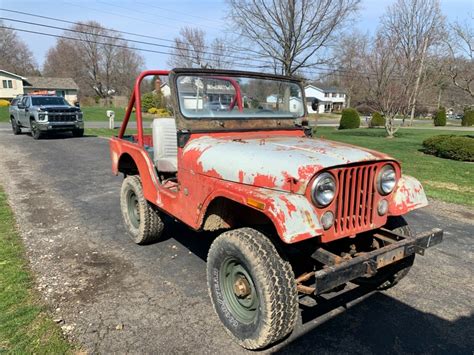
[304,85,346,113]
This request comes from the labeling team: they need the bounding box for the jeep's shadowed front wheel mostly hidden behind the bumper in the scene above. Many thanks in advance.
[352,217,415,290]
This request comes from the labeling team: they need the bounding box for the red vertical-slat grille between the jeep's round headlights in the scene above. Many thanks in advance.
[334,165,377,236]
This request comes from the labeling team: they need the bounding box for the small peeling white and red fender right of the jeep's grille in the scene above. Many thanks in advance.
[388,175,428,216]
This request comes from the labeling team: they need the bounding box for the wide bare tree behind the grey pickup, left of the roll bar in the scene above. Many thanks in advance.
[44,21,143,98]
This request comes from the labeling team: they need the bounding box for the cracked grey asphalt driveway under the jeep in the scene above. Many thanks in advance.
[0,130,474,354]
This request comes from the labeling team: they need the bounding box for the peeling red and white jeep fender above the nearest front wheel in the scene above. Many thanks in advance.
[200,182,323,243]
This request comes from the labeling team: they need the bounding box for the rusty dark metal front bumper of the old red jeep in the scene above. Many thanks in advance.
[296,228,443,295]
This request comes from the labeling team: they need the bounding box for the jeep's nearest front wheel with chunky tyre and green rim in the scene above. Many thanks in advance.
[207,228,298,349]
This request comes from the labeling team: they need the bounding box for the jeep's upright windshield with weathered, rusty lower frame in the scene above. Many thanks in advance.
[169,68,307,132]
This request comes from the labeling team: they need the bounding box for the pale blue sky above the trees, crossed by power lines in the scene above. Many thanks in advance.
[0,0,474,69]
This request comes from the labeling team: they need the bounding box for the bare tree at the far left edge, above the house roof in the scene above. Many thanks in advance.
[0,21,39,75]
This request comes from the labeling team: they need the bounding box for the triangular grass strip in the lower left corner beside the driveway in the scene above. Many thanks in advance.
[0,189,74,354]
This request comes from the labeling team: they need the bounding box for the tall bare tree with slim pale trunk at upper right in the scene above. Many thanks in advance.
[381,0,444,124]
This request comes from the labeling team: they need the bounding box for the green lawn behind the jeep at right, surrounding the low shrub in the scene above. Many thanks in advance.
[316,127,474,206]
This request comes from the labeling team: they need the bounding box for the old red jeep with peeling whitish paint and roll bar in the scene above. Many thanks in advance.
[110,69,443,349]
